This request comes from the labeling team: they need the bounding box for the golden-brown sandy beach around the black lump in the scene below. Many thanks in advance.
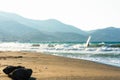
[0,52,120,80]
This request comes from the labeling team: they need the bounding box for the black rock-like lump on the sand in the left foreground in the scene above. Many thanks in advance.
[3,66,32,80]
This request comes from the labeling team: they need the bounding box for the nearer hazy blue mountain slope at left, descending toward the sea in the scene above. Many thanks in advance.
[0,21,56,42]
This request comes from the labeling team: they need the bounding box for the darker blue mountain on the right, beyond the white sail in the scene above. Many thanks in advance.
[90,27,120,42]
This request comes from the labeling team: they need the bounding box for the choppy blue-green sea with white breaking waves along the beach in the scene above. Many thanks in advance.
[0,42,120,67]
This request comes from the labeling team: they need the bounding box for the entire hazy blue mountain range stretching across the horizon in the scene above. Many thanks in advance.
[0,12,120,42]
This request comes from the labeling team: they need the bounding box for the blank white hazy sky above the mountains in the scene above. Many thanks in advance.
[0,0,120,30]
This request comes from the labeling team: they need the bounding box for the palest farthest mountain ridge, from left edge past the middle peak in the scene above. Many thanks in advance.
[0,12,86,34]
